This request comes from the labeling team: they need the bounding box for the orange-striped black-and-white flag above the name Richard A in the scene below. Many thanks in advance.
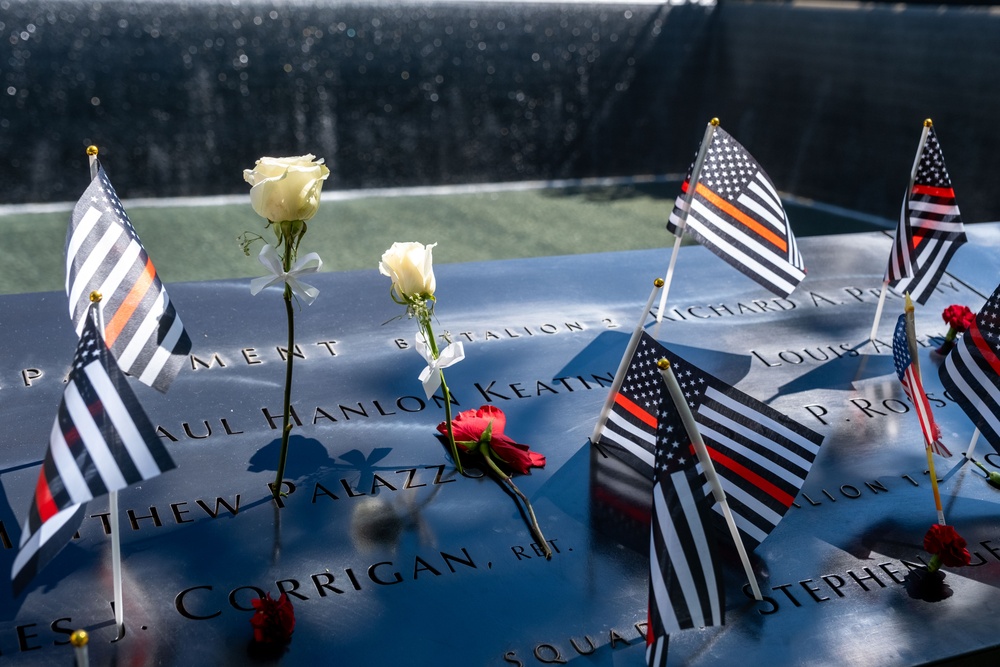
[667,127,806,296]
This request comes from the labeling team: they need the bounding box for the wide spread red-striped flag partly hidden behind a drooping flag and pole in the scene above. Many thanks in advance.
[601,333,823,550]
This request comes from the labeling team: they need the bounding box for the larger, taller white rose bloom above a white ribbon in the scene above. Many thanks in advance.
[243,154,330,222]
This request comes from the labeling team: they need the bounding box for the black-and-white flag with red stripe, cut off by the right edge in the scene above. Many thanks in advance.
[938,287,1000,452]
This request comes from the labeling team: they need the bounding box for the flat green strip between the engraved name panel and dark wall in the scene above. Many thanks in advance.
[0,182,892,294]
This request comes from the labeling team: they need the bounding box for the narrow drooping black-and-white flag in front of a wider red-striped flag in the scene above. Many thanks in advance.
[646,360,725,656]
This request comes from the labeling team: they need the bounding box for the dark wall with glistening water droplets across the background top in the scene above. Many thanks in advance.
[0,0,1000,221]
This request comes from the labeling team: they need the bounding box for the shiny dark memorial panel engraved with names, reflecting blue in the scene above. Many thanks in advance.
[0,225,1000,665]
